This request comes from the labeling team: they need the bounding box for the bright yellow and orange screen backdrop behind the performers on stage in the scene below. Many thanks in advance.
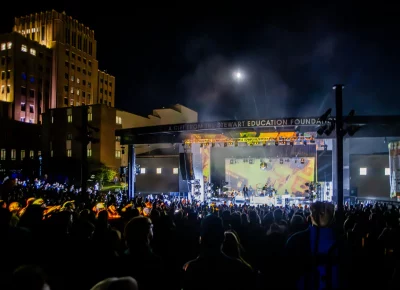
[225,157,315,196]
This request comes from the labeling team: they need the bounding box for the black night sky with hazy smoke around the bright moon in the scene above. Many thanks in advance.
[0,1,400,121]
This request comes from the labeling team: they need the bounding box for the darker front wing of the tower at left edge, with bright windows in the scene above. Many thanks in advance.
[0,32,52,124]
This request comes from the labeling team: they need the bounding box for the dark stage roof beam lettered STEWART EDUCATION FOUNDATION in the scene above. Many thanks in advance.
[115,116,400,145]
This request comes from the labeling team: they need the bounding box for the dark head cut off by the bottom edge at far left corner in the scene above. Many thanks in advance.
[12,266,50,290]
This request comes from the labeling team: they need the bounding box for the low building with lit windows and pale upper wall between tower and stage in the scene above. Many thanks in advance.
[42,104,197,179]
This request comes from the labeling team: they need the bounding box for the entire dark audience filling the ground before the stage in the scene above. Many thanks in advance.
[0,181,400,290]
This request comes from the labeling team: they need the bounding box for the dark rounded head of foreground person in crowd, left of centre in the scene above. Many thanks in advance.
[125,216,153,248]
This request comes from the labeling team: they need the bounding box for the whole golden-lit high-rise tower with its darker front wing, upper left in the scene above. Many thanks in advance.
[0,10,115,123]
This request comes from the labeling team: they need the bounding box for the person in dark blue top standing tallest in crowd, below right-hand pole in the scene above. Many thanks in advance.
[286,201,351,290]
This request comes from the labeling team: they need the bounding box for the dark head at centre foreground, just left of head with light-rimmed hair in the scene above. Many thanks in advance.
[200,215,224,249]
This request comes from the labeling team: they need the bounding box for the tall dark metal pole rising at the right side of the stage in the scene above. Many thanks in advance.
[333,84,344,212]
